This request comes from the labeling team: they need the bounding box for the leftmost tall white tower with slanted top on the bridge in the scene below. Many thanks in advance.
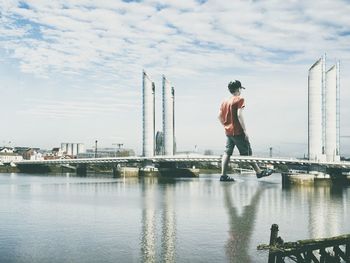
[142,71,155,157]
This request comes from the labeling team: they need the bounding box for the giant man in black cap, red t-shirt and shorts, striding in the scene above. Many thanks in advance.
[219,80,272,181]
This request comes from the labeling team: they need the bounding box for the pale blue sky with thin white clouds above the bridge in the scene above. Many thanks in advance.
[0,0,350,156]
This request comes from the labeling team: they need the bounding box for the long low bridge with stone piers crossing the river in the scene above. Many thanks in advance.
[12,154,350,180]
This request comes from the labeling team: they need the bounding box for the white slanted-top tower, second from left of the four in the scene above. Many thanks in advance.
[163,75,175,155]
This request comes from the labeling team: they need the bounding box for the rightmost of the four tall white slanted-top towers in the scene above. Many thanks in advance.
[324,62,340,162]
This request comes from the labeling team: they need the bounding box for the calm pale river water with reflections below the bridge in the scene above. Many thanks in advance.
[0,174,350,263]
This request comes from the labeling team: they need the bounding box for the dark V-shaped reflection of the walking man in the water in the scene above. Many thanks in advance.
[223,184,262,262]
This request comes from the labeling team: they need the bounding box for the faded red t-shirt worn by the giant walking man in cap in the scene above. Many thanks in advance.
[219,96,245,135]
